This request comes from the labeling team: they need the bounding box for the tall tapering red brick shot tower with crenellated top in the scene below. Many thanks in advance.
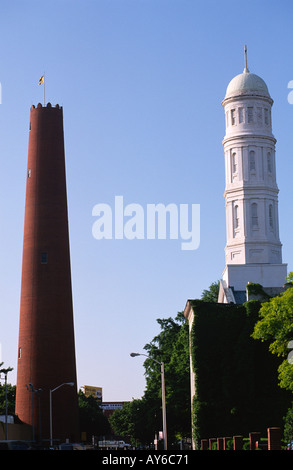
[15,103,78,442]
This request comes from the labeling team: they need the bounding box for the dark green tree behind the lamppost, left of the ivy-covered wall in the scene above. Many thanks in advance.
[110,312,191,446]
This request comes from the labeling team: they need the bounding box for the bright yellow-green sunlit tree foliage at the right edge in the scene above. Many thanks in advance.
[252,273,293,392]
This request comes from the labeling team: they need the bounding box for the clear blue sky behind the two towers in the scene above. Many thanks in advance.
[0,0,293,400]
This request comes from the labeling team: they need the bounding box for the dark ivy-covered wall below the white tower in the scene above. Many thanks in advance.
[189,300,292,448]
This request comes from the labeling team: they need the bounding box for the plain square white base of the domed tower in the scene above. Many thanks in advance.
[218,264,287,304]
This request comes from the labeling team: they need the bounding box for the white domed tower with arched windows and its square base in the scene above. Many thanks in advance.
[219,46,287,303]
